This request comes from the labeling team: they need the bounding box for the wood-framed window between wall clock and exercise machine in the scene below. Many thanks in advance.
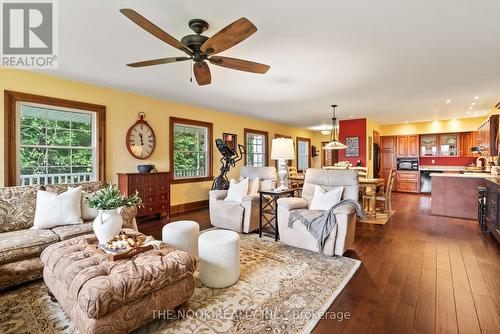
[170,117,212,183]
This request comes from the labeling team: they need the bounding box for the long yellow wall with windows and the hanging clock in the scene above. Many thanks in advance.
[0,69,320,205]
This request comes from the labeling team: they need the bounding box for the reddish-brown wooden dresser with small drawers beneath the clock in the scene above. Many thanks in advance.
[118,172,170,219]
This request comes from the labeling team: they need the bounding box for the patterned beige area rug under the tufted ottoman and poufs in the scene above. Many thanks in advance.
[0,235,361,334]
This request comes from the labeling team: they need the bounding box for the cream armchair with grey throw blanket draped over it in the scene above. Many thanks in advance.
[278,168,359,256]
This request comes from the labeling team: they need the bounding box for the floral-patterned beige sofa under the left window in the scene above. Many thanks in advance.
[0,182,137,290]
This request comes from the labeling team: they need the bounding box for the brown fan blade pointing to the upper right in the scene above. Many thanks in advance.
[201,17,257,54]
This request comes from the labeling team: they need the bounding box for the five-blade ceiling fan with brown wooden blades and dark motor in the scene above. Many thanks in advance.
[120,8,270,86]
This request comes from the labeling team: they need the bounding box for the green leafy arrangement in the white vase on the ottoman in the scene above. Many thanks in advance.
[85,183,143,210]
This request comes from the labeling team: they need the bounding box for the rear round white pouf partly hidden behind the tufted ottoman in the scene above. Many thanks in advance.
[161,220,200,258]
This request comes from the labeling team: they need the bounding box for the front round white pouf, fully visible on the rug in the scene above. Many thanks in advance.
[198,230,240,288]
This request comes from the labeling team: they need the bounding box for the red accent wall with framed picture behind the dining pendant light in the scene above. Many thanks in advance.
[339,118,366,166]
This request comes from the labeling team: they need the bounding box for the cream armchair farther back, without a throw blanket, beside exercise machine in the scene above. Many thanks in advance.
[209,166,276,233]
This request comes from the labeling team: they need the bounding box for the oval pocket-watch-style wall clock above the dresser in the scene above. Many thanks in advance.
[125,111,156,159]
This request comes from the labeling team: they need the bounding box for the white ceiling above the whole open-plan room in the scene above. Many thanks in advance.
[42,0,500,127]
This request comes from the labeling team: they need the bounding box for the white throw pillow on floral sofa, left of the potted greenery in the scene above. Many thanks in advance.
[33,187,83,230]
